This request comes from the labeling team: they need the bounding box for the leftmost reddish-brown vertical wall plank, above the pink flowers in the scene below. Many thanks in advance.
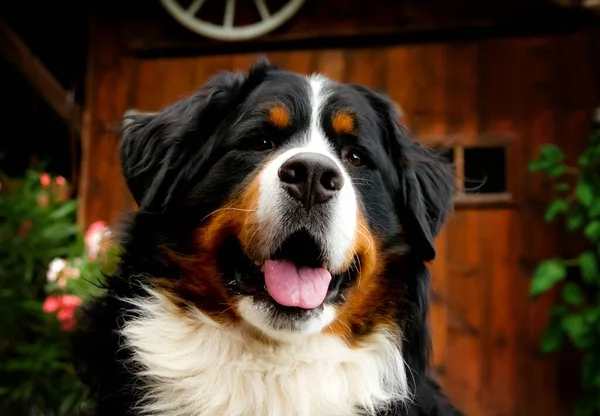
[78,13,136,226]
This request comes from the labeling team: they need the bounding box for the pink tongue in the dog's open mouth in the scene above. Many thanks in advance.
[265,260,331,309]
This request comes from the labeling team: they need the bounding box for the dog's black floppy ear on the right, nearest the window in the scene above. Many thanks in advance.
[355,86,455,261]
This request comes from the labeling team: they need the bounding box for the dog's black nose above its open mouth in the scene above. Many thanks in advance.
[278,152,344,211]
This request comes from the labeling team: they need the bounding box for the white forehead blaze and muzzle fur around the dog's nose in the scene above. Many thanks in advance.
[257,76,357,273]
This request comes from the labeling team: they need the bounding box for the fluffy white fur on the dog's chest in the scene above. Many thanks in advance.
[122,292,409,416]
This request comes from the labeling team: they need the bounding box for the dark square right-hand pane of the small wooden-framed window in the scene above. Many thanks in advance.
[464,147,507,194]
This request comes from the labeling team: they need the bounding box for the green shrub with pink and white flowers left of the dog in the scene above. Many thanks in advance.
[0,171,118,416]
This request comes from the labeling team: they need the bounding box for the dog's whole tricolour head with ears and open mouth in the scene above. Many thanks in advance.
[122,58,453,340]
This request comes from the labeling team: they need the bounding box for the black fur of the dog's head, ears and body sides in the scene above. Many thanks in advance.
[74,61,458,416]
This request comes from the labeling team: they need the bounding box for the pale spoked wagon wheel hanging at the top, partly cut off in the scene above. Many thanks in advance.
[160,0,305,41]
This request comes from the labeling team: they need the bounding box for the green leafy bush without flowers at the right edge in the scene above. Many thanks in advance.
[529,114,600,415]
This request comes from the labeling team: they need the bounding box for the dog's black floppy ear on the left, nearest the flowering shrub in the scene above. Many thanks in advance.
[120,58,276,211]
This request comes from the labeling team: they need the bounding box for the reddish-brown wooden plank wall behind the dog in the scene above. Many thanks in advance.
[81,14,600,416]
